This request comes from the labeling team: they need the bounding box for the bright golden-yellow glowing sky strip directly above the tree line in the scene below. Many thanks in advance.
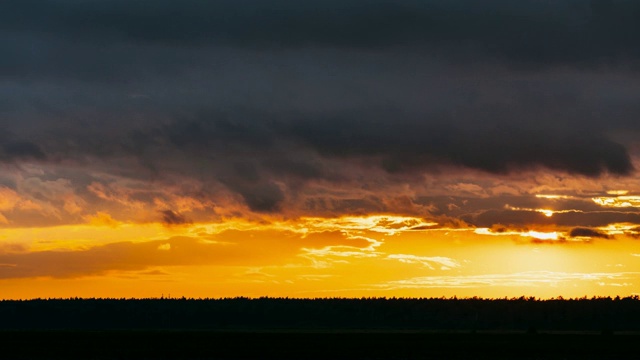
[0,213,640,298]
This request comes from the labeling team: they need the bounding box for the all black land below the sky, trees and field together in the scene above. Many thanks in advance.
[0,297,640,360]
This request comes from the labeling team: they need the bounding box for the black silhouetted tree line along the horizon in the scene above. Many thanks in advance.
[0,296,640,332]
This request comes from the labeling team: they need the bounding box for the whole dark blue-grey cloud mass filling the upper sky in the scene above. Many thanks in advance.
[0,0,640,212]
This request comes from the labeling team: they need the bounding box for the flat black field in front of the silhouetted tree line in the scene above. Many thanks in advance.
[0,330,640,359]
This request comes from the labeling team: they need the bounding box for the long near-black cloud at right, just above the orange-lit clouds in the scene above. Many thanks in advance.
[292,113,632,176]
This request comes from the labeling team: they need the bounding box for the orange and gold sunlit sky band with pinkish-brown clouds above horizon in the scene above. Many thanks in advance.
[0,160,640,299]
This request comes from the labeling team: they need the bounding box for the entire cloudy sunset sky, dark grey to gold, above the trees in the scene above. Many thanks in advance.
[0,0,640,299]
